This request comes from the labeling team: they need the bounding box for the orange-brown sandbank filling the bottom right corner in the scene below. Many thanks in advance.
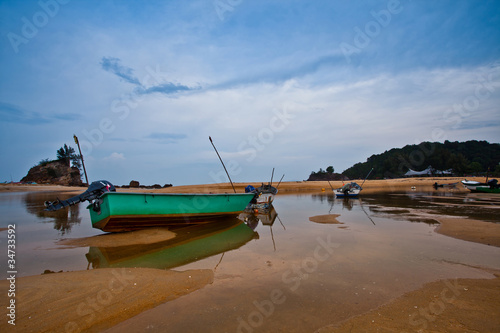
[317,272,500,333]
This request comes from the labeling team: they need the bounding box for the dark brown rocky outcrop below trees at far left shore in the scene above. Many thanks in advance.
[21,161,83,186]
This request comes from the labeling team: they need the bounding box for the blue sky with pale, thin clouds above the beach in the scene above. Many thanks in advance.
[0,0,500,185]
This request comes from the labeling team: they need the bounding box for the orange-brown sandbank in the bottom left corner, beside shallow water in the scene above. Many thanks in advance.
[0,268,214,332]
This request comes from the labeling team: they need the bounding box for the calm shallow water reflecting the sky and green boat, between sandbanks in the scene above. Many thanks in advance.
[0,191,500,332]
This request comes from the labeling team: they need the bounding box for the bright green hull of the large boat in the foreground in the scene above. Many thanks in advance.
[87,192,254,232]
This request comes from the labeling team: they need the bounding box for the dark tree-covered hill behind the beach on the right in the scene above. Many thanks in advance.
[343,140,500,179]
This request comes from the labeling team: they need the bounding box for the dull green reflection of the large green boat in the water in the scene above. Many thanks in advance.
[86,218,258,269]
